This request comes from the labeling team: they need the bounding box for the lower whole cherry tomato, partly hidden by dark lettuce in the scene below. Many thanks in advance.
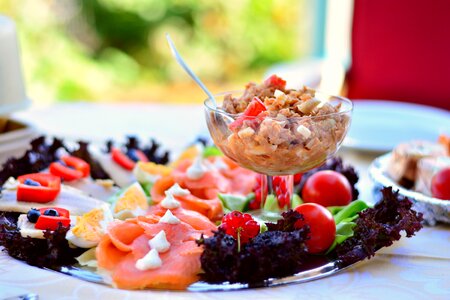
[295,203,336,254]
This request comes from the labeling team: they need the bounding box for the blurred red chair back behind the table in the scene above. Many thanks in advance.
[346,0,450,110]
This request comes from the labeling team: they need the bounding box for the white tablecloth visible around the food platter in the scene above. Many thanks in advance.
[0,103,450,300]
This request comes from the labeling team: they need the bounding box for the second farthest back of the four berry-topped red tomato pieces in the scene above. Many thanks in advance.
[49,155,91,181]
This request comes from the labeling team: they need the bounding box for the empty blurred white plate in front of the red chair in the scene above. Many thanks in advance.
[344,100,450,152]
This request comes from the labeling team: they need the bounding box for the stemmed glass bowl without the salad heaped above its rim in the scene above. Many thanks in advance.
[204,92,353,214]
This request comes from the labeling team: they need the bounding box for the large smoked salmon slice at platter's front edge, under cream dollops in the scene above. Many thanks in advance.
[96,209,217,290]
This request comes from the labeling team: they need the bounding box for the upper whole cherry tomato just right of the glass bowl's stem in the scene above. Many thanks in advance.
[302,170,352,206]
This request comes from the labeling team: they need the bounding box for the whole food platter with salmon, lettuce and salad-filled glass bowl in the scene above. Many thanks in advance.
[0,75,423,291]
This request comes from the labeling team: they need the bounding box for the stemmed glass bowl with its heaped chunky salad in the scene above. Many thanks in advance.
[204,77,353,213]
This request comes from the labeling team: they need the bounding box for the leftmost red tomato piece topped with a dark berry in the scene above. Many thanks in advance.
[16,173,61,203]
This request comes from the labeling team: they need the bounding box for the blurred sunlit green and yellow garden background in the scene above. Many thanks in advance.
[0,0,308,103]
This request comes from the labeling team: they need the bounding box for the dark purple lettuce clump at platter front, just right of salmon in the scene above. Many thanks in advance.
[197,213,309,284]
